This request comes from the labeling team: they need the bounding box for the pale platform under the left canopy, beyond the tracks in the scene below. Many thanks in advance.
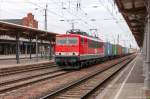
[0,55,54,69]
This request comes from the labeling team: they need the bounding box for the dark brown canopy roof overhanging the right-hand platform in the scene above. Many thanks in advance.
[115,0,147,47]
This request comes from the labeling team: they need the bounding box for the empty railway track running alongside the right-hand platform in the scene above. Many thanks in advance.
[40,56,135,99]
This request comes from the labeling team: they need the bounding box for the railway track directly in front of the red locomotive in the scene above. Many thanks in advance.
[0,69,68,94]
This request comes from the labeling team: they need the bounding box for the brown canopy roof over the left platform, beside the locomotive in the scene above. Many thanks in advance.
[0,21,58,41]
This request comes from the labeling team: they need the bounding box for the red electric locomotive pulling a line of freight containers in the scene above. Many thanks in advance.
[55,31,128,69]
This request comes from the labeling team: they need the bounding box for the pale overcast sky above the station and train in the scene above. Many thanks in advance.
[0,0,137,48]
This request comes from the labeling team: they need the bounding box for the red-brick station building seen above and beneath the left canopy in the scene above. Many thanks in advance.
[0,13,54,56]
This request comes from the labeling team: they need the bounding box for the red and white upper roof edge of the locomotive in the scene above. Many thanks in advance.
[57,34,103,42]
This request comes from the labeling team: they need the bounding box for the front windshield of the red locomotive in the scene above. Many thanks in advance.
[56,37,78,45]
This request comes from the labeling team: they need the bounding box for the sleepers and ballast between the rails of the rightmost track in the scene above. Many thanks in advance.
[48,58,132,99]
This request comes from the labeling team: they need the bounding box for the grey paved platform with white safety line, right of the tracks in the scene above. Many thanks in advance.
[96,54,150,99]
